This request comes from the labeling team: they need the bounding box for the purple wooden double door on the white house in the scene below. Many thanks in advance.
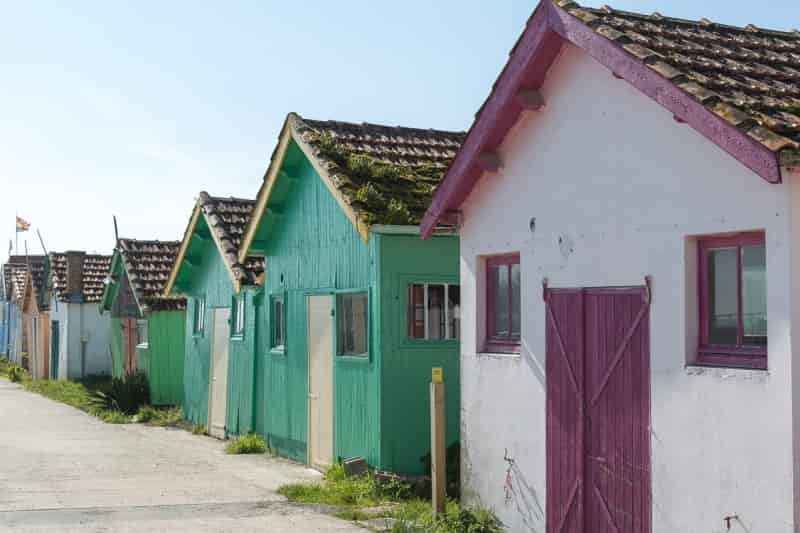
[545,287,651,533]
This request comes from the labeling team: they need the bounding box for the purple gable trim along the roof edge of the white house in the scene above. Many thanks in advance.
[421,0,781,238]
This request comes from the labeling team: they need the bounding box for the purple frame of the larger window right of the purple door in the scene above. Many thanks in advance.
[697,231,769,370]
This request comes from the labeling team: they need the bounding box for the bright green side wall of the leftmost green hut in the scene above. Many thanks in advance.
[136,311,186,405]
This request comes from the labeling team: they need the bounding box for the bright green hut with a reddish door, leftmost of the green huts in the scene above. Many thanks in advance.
[102,239,186,405]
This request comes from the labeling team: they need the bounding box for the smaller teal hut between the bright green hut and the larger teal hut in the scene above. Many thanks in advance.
[165,192,264,438]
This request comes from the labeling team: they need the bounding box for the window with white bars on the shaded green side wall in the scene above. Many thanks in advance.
[407,283,461,339]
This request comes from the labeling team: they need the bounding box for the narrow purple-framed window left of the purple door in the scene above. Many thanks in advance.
[486,254,522,352]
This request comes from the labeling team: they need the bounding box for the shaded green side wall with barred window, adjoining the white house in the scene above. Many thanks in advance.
[379,235,461,474]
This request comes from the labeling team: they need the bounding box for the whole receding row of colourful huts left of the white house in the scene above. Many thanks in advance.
[0,114,463,474]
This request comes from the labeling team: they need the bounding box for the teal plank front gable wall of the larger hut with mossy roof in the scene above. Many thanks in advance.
[256,146,380,464]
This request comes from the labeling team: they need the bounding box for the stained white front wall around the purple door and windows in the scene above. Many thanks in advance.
[461,47,800,533]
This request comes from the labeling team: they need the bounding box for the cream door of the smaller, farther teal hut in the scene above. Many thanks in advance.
[208,307,231,439]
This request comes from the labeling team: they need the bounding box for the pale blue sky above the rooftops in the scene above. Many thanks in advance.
[0,0,800,257]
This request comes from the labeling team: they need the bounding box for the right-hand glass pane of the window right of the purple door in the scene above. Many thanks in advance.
[742,245,767,346]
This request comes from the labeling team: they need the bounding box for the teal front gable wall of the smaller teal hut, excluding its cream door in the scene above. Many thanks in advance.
[181,231,233,426]
